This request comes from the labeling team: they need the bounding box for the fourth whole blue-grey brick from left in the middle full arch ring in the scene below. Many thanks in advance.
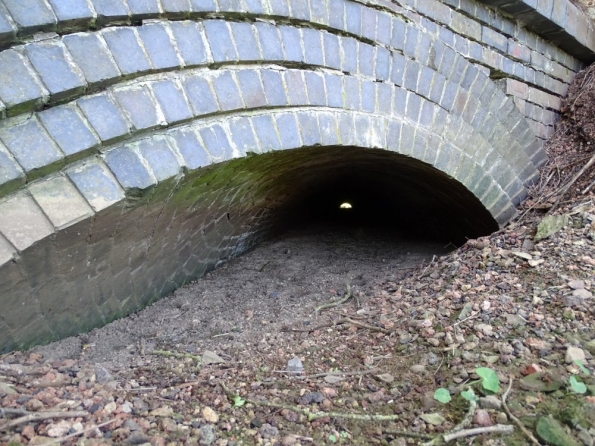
[113,86,165,130]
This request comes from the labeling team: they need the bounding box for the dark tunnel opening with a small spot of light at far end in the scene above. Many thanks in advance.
[251,147,498,248]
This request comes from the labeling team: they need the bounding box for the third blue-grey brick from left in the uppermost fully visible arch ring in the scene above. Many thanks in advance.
[62,33,122,87]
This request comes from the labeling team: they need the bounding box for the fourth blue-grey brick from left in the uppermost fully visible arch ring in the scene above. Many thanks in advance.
[101,28,152,76]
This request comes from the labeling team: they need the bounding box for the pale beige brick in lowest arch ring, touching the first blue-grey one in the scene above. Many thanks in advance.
[29,176,93,229]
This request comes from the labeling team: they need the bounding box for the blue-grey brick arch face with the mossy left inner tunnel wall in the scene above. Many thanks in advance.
[0,0,594,351]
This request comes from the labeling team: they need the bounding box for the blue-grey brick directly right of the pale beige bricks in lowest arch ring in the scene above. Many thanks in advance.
[66,161,126,212]
